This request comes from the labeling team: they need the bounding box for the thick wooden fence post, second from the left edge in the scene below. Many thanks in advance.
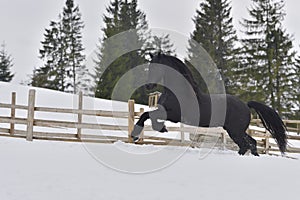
[26,90,35,141]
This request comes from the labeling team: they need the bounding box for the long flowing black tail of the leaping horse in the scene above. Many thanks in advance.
[248,101,287,153]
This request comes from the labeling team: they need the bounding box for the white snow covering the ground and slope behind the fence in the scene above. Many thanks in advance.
[0,83,300,200]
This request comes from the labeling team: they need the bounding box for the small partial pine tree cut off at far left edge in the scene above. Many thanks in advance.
[0,42,14,82]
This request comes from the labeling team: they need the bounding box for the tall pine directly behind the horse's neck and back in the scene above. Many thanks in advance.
[187,0,238,93]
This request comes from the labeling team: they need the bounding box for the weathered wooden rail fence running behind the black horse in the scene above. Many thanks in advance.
[0,90,300,154]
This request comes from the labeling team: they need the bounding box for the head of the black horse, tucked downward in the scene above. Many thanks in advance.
[146,53,165,90]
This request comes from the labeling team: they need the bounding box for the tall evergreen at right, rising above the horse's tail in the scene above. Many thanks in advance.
[239,0,297,115]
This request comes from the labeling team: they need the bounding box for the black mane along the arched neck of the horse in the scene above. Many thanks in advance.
[163,55,200,96]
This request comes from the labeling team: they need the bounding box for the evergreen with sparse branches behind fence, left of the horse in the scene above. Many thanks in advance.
[31,0,88,93]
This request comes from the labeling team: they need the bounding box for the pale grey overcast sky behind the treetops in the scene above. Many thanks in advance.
[0,0,300,83]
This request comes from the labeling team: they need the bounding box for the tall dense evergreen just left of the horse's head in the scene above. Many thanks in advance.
[95,0,149,103]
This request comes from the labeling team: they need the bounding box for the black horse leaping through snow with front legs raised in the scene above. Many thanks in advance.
[131,53,287,156]
